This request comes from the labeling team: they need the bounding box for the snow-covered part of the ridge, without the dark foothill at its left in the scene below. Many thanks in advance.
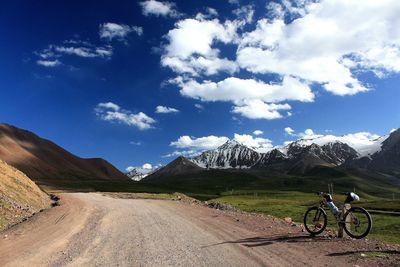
[190,129,393,173]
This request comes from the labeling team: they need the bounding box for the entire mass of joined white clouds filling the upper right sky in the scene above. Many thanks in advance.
[161,0,400,119]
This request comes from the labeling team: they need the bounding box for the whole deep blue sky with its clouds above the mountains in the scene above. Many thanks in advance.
[0,0,400,170]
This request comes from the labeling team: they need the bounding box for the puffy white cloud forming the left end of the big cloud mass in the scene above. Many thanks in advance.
[161,16,238,76]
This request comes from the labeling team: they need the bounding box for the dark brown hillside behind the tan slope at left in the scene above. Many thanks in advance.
[0,124,128,184]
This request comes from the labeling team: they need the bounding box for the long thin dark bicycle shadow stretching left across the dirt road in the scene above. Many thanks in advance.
[204,235,341,247]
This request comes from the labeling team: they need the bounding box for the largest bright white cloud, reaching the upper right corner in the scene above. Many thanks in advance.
[237,0,400,95]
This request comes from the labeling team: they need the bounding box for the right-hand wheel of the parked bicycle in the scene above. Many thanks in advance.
[343,207,372,239]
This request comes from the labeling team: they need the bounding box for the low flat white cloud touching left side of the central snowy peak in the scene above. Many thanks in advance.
[170,135,229,150]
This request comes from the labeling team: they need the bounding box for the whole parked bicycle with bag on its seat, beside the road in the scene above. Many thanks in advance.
[304,192,372,239]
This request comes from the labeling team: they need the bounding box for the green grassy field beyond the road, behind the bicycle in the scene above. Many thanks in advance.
[212,191,400,243]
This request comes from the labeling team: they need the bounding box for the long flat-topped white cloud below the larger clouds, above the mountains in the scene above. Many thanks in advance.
[173,77,314,119]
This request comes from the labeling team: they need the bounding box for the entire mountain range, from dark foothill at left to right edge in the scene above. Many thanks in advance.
[146,129,400,180]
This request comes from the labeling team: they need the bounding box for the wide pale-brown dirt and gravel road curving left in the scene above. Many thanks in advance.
[0,193,400,266]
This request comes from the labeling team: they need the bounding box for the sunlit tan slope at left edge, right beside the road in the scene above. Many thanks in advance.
[0,160,50,231]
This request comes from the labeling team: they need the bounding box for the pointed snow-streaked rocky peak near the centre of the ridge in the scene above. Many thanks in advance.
[191,140,261,169]
